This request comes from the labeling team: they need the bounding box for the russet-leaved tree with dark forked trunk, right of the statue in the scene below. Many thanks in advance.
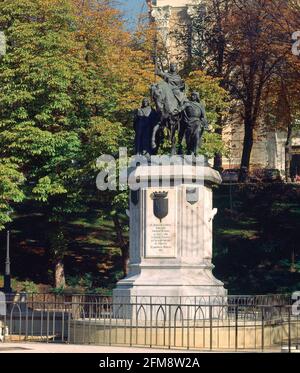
[190,0,295,177]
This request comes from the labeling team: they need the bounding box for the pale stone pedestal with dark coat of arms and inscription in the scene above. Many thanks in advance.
[113,165,227,312]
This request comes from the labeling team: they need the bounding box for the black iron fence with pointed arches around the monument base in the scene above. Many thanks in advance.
[0,293,300,352]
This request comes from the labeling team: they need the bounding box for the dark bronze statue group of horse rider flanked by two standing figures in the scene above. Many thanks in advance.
[134,64,208,156]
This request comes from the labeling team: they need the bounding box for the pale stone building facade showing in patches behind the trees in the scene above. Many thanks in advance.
[147,0,300,176]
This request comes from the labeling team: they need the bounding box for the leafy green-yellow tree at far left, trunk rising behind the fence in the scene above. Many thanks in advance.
[0,0,91,287]
